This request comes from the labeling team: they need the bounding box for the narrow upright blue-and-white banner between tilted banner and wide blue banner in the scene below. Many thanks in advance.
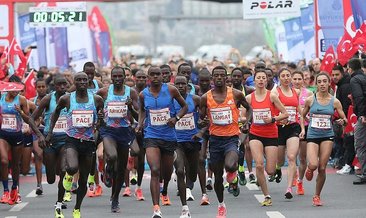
[301,4,315,61]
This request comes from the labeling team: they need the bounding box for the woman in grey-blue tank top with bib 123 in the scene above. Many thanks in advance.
[300,73,347,206]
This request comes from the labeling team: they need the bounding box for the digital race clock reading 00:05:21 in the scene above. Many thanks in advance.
[29,4,87,27]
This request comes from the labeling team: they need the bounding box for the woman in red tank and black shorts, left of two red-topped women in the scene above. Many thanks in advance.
[246,70,288,206]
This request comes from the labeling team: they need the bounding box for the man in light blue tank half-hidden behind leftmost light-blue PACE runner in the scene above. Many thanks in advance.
[30,75,67,217]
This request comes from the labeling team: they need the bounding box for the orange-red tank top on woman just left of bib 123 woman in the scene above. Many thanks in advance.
[276,87,299,125]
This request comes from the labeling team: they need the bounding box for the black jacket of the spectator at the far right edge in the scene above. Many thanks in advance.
[350,70,366,117]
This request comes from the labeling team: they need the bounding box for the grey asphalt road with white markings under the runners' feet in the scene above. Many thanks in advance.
[0,168,366,218]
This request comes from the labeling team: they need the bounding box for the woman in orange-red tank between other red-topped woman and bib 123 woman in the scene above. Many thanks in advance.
[269,68,301,199]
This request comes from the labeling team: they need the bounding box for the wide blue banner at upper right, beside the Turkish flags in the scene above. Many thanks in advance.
[315,0,344,57]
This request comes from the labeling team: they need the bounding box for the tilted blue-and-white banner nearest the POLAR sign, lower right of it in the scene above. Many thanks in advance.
[283,17,305,61]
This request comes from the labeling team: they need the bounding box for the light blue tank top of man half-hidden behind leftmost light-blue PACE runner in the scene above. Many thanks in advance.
[44,92,67,135]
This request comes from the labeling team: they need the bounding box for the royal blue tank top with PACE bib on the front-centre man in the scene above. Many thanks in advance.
[143,83,177,141]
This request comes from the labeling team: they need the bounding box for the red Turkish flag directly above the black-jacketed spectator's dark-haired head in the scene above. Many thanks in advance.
[337,31,358,66]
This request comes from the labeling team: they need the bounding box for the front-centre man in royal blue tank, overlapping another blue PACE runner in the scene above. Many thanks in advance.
[136,67,187,218]
